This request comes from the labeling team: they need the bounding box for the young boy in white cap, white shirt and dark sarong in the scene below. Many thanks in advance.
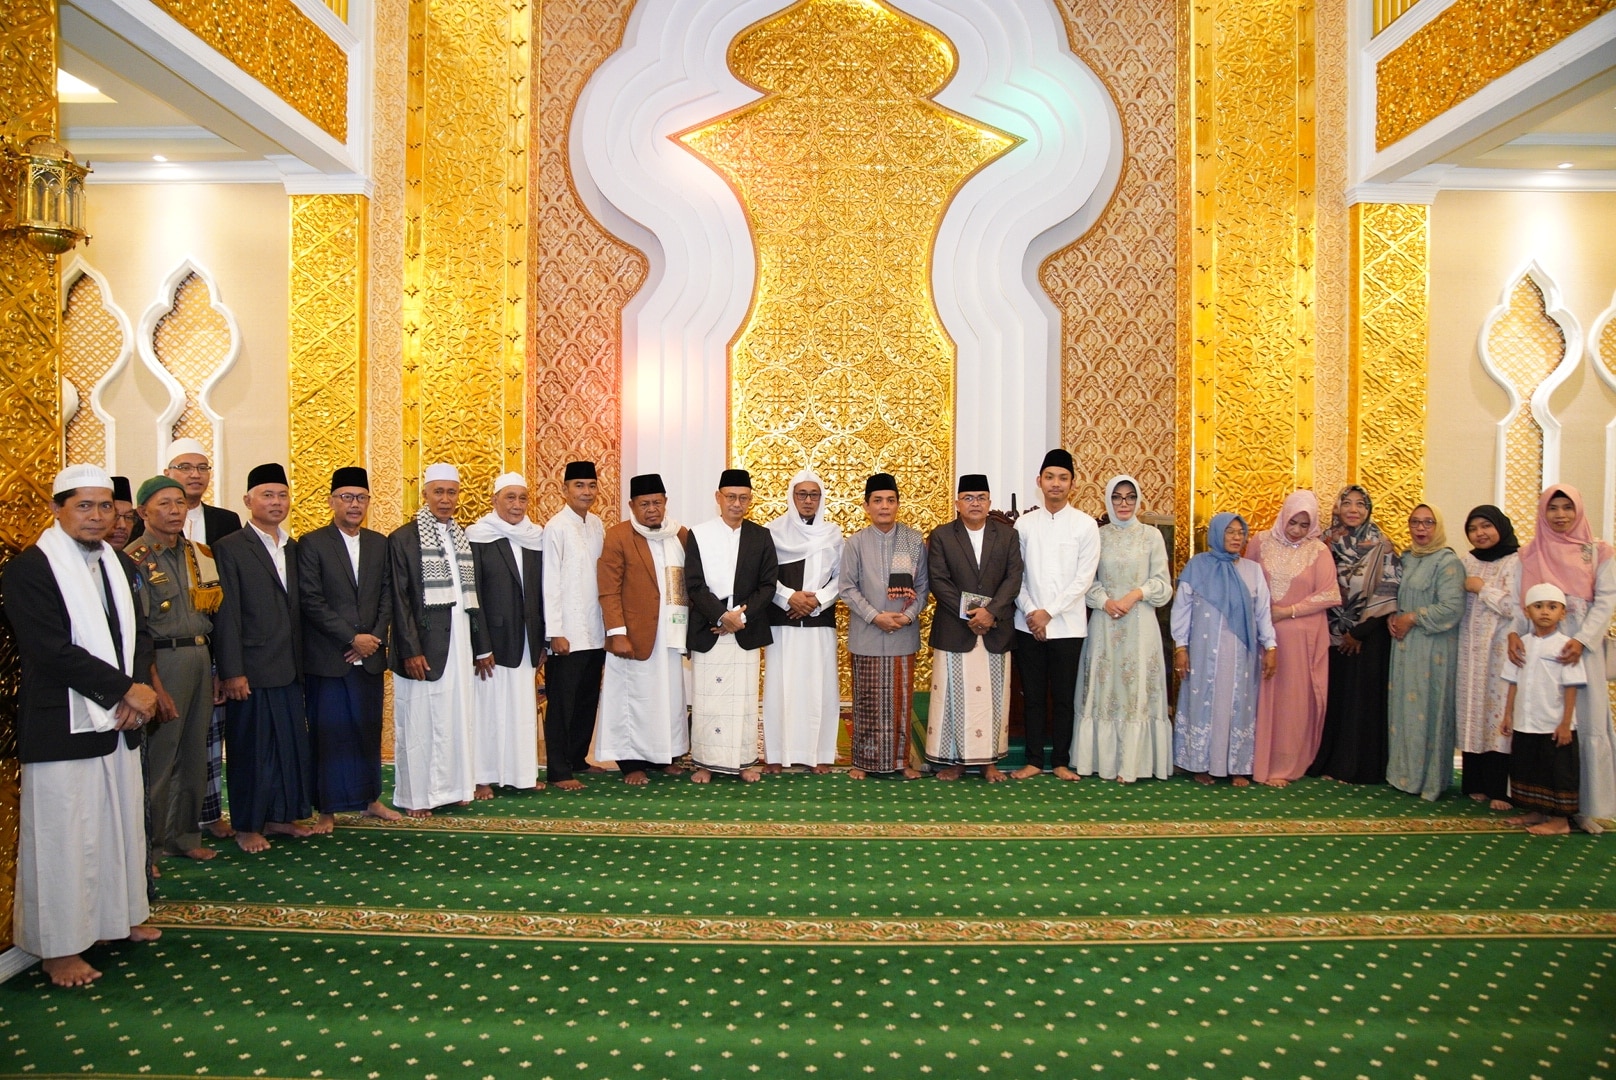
[1500,582,1587,836]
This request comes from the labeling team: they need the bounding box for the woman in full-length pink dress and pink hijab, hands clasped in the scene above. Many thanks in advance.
[1246,491,1341,787]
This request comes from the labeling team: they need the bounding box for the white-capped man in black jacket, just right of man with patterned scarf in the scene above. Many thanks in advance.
[465,472,545,799]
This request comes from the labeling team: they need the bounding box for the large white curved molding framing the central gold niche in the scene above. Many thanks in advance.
[570,0,1123,516]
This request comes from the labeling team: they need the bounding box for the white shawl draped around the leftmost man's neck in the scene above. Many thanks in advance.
[39,524,134,736]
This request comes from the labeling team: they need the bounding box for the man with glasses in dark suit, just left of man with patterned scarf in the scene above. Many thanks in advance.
[297,467,401,833]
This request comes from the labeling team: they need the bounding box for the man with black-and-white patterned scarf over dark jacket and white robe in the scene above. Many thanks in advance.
[388,464,494,818]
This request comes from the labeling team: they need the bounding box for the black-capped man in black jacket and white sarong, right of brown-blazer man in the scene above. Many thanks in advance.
[685,469,779,784]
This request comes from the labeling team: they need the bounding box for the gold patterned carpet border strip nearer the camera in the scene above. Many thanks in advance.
[152,904,1616,946]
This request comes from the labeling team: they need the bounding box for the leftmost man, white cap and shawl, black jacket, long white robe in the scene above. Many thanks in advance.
[0,466,158,986]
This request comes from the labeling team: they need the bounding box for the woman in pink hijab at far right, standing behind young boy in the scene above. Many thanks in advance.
[1509,483,1616,833]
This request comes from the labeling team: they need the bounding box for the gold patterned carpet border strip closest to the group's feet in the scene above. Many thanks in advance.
[336,813,1521,841]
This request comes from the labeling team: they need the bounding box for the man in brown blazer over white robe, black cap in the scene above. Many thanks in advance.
[595,472,690,784]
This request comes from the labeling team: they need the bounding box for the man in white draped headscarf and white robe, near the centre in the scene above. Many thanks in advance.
[763,469,842,773]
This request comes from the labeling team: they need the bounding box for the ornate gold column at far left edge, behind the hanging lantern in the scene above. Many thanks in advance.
[0,0,61,946]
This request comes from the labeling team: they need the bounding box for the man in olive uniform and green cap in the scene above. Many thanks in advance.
[124,477,221,876]
